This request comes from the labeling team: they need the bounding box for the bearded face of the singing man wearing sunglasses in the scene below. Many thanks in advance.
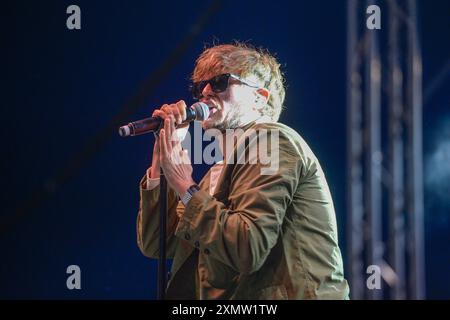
[200,74,257,131]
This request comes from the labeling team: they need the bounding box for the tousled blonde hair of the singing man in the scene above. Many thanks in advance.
[192,42,285,121]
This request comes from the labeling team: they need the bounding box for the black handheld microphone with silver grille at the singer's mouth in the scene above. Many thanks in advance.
[119,102,209,137]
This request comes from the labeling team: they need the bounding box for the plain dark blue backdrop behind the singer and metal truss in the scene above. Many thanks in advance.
[0,0,450,299]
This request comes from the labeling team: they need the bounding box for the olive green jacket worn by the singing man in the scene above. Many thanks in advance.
[137,123,349,299]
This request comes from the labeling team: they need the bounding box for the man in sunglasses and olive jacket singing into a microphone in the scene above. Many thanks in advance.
[137,43,349,299]
